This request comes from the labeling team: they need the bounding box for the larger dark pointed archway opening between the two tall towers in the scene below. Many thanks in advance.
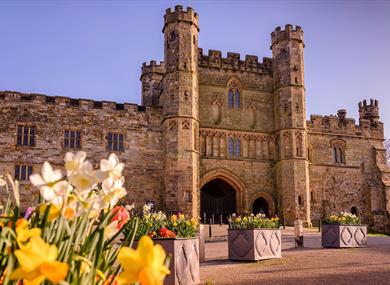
[200,178,237,223]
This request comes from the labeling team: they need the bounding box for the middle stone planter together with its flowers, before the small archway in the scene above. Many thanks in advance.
[228,214,282,261]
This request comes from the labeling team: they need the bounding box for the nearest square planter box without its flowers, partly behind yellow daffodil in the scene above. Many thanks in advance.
[134,237,200,285]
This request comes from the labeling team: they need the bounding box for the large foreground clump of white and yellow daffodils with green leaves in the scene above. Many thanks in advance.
[0,152,170,285]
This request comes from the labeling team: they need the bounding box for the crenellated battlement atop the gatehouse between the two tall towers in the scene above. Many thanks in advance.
[198,48,272,74]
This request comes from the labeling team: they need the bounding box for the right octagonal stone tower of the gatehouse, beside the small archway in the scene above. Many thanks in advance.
[271,25,310,224]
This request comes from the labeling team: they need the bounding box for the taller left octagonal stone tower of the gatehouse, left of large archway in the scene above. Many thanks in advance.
[162,6,199,216]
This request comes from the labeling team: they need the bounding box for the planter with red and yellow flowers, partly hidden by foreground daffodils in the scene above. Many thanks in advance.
[125,205,200,285]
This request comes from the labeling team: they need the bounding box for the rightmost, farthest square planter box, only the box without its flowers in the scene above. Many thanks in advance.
[321,224,367,248]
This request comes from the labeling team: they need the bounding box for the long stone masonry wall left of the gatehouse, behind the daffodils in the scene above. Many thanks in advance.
[0,92,164,207]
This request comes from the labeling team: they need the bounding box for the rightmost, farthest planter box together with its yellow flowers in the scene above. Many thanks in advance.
[321,212,367,248]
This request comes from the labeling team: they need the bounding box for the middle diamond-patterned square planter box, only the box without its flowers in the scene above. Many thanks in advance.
[228,229,282,261]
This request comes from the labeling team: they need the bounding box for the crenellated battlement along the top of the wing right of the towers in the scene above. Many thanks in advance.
[306,105,383,138]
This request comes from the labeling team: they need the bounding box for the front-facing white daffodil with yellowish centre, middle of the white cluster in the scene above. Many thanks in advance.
[68,161,99,196]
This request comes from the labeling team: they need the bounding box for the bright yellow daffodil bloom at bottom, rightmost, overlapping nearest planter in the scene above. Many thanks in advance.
[118,236,170,285]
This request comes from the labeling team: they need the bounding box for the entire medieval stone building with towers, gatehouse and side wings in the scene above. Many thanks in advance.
[0,6,390,230]
